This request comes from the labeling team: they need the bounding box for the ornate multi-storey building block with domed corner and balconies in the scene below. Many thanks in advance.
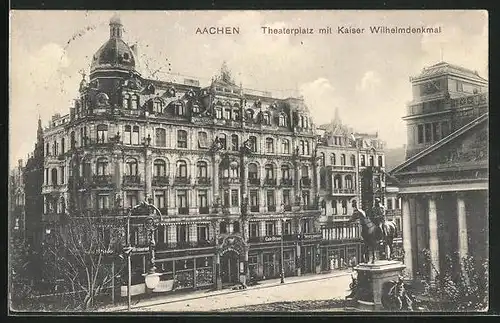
[34,18,383,289]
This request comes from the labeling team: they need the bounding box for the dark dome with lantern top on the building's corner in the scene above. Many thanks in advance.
[90,15,135,71]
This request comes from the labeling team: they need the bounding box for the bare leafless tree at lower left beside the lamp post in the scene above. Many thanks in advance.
[44,217,124,310]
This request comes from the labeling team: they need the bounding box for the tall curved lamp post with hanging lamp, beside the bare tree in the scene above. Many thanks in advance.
[123,199,162,311]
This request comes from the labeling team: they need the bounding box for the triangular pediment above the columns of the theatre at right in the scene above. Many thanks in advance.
[392,118,488,176]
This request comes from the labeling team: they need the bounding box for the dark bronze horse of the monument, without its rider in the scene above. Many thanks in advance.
[349,201,397,264]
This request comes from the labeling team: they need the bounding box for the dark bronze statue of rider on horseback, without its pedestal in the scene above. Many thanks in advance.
[349,198,397,264]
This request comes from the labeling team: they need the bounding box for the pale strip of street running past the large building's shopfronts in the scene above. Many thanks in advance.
[100,270,352,312]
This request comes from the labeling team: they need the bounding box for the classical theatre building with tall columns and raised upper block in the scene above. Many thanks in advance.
[391,62,488,279]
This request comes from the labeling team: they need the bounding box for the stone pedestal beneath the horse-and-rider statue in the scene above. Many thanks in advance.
[352,260,406,311]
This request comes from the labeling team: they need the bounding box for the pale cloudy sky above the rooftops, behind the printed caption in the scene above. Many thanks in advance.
[9,10,488,165]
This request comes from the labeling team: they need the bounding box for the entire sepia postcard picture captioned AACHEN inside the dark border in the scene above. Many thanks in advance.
[8,10,490,315]
